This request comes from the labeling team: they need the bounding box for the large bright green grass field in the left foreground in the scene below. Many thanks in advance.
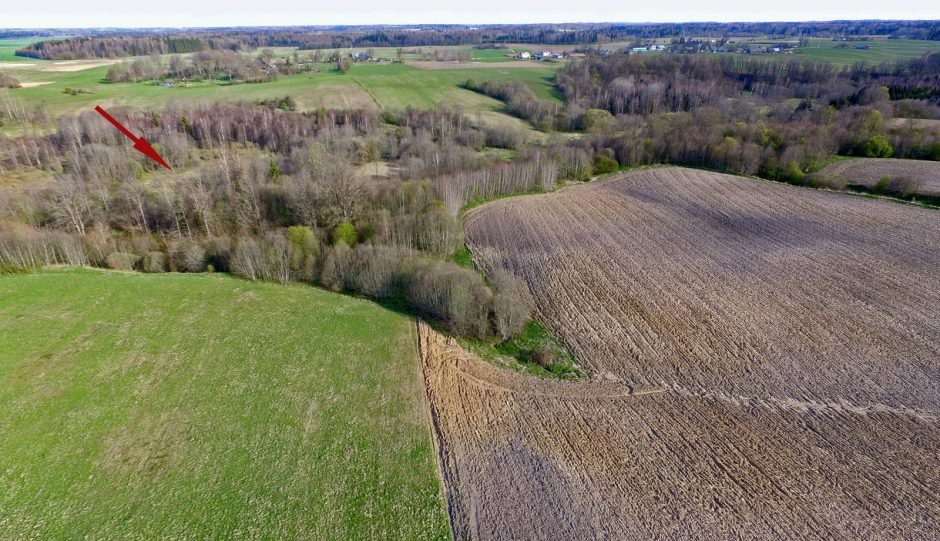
[0,269,449,540]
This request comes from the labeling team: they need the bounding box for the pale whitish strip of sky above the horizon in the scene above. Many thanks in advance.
[0,0,940,28]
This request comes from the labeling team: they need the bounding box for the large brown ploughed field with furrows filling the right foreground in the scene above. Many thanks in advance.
[419,168,940,539]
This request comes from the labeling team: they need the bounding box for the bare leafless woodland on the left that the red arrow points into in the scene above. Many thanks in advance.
[0,105,589,337]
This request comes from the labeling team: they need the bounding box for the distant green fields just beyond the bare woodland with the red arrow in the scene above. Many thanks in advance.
[0,40,559,123]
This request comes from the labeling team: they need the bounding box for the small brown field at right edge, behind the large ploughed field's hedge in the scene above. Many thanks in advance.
[822,158,940,195]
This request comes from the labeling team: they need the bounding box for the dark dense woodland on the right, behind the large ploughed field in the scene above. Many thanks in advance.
[555,54,940,187]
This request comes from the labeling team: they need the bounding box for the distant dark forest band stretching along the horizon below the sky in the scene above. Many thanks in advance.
[14,21,940,60]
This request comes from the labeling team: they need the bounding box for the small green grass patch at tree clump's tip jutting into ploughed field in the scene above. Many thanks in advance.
[458,320,585,379]
